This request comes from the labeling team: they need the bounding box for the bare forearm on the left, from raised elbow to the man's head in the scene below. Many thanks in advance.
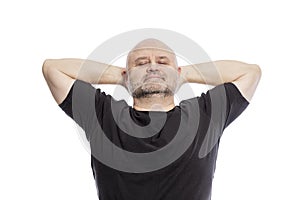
[43,58,123,84]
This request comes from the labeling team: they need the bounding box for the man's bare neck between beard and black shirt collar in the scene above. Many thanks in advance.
[133,94,175,112]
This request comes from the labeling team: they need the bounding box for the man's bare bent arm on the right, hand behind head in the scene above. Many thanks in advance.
[181,60,261,102]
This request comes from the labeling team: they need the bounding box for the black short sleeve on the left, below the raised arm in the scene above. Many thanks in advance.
[59,80,107,141]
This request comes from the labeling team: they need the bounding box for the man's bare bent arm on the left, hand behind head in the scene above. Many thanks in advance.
[43,59,125,104]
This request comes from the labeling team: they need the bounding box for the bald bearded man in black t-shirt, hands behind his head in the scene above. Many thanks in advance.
[43,39,261,200]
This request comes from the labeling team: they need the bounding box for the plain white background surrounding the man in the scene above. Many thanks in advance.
[0,0,300,200]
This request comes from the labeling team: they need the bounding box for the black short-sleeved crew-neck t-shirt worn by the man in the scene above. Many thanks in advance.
[59,80,249,200]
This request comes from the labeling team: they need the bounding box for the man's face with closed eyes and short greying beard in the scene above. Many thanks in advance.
[127,48,180,98]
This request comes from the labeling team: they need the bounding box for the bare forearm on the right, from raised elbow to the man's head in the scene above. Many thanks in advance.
[181,60,259,85]
